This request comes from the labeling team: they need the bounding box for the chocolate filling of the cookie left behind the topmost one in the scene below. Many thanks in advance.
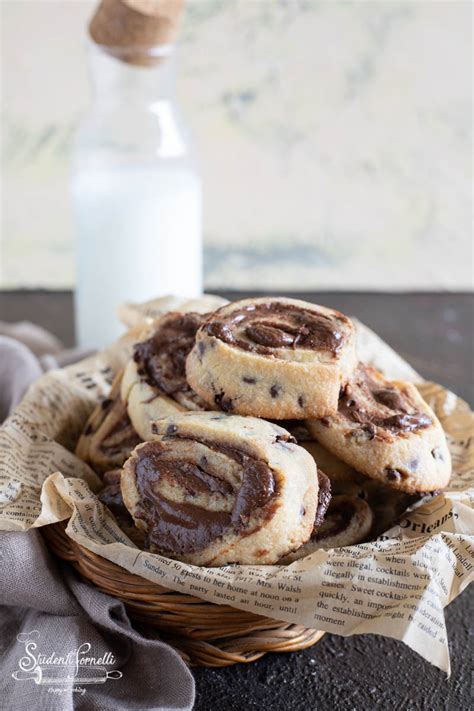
[133,313,207,409]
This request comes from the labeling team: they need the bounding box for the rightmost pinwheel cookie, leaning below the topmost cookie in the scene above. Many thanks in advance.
[306,364,451,493]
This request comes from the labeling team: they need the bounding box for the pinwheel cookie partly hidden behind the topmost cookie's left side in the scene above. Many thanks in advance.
[121,312,208,440]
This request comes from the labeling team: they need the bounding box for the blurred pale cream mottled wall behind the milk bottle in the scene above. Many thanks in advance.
[0,0,472,290]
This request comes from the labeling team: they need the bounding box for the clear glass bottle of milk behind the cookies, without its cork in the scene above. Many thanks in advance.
[72,42,202,348]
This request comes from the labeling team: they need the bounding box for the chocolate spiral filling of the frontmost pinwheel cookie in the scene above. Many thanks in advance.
[131,435,278,557]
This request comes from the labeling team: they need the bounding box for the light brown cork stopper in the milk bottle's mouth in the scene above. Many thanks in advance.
[89,0,184,66]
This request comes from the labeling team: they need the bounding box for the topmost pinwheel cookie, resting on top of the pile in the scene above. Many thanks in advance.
[186,297,356,420]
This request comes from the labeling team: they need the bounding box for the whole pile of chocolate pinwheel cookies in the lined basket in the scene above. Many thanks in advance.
[76,297,451,566]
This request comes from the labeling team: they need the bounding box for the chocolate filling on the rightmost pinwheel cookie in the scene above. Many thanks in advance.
[338,365,432,439]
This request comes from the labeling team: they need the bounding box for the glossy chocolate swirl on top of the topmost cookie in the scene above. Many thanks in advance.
[204,301,348,354]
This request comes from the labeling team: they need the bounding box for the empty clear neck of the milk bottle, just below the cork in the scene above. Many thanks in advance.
[89,42,175,105]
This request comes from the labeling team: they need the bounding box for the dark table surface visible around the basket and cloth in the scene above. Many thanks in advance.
[0,291,474,711]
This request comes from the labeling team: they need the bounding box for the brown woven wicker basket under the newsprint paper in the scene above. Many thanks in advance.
[42,523,324,667]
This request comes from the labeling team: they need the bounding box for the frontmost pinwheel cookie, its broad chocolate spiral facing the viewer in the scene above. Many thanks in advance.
[121,412,318,566]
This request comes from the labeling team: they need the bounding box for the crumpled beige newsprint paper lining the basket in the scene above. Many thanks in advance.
[0,318,474,674]
